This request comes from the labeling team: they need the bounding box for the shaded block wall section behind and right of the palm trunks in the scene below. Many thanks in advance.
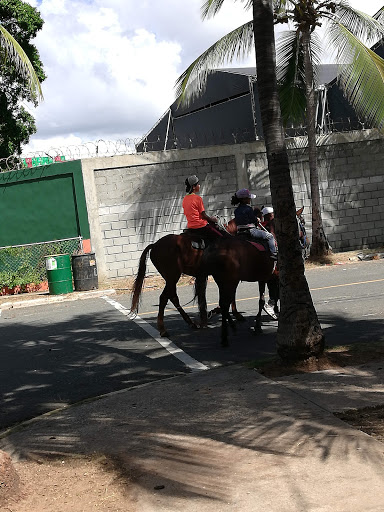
[247,132,384,251]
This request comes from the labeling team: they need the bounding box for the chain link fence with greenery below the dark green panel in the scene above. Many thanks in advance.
[0,237,83,291]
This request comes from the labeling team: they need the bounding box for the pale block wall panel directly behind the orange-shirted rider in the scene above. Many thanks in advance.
[83,148,237,279]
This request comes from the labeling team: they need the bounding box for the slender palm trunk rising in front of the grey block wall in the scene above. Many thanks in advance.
[302,29,330,260]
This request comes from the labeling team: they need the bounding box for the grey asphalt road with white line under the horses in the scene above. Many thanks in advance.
[0,260,384,429]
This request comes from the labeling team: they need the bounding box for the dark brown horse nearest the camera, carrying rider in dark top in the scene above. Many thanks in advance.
[195,237,275,346]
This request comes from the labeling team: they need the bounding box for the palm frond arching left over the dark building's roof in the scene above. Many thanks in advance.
[175,21,254,104]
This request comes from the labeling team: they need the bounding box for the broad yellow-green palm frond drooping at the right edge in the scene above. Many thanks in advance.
[333,24,384,128]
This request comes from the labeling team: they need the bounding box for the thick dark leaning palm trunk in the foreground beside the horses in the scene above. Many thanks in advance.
[253,0,324,360]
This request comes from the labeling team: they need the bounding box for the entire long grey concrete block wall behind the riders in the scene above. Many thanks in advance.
[82,132,384,279]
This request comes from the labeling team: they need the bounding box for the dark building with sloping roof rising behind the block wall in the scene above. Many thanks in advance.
[136,61,381,152]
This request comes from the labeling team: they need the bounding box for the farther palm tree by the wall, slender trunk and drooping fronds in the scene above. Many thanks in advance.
[274,0,384,259]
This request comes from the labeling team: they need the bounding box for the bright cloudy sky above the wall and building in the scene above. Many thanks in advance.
[24,0,384,155]
